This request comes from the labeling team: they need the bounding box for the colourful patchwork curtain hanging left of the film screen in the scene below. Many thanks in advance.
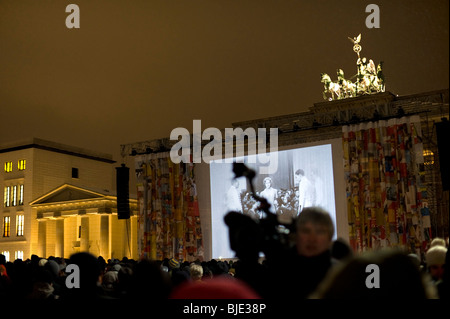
[135,153,203,261]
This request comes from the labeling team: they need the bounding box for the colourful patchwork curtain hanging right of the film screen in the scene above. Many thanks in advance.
[342,116,431,256]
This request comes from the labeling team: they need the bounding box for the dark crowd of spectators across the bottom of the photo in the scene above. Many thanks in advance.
[0,208,449,300]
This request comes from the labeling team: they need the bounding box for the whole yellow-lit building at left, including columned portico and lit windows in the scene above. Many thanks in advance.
[0,138,137,261]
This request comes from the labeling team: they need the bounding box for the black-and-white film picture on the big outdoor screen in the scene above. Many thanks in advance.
[210,144,336,258]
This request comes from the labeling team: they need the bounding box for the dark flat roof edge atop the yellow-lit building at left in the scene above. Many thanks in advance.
[0,138,116,164]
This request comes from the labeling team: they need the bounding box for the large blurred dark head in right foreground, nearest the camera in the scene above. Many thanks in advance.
[311,249,437,301]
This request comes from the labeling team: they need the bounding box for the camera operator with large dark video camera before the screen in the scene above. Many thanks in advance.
[225,163,334,300]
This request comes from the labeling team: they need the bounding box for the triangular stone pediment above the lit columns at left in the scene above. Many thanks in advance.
[30,184,108,205]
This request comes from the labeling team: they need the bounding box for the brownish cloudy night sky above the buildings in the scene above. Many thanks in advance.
[0,0,449,161]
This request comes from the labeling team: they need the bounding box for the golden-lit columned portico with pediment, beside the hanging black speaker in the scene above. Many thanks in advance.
[30,184,137,259]
